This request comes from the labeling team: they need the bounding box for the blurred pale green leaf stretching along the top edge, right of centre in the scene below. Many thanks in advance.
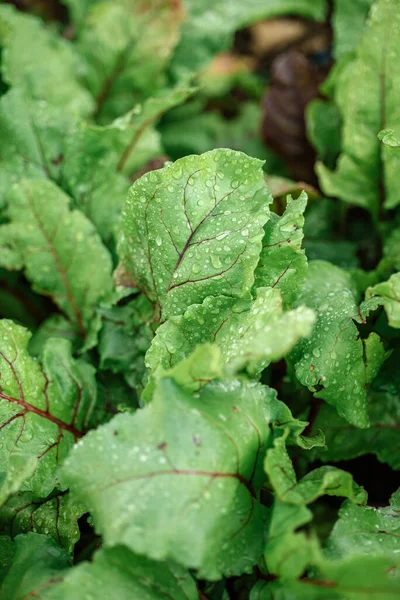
[171,0,326,75]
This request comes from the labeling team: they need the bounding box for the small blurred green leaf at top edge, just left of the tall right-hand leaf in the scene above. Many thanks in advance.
[332,0,373,60]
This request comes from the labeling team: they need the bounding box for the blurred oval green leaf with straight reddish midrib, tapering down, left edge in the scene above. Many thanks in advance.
[0,180,112,337]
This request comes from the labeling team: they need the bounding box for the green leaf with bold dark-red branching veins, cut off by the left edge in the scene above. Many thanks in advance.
[0,320,96,504]
